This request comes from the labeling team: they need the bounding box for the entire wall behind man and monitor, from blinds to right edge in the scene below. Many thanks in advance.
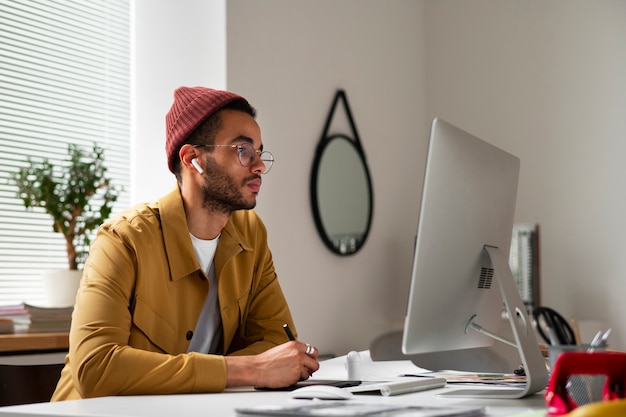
[135,0,626,354]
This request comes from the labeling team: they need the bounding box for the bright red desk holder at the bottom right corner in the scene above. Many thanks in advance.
[545,346,626,416]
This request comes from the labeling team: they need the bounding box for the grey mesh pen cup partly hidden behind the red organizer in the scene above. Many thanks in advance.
[548,344,606,405]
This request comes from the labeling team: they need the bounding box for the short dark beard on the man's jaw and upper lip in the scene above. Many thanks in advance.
[202,158,259,214]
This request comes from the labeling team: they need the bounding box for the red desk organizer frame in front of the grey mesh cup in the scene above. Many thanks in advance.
[545,352,626,416]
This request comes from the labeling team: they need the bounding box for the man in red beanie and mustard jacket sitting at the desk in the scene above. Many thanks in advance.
[52,87,319,401]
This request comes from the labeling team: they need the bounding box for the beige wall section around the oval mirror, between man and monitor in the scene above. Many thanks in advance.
[226,0,426,354]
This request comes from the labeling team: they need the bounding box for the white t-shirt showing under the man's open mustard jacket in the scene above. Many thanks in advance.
[187,233,222,353]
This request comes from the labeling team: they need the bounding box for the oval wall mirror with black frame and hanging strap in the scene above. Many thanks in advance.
[311,90,373,255]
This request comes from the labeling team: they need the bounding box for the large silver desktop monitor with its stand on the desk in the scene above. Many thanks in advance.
[402,119,547,398]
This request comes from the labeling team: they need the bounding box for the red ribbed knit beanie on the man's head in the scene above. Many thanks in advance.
[165,87,247,172]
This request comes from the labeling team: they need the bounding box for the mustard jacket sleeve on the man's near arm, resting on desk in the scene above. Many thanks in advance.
[53,219,226,399]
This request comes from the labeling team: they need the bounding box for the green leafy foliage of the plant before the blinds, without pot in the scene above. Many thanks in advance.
[13,144,121,301]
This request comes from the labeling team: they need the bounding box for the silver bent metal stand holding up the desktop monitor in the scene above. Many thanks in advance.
[440,246,548,398]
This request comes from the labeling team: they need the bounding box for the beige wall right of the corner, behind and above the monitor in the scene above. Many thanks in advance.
[425,0,626,349]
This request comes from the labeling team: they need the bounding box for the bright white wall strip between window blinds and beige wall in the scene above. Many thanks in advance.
[130,0,226,203]
